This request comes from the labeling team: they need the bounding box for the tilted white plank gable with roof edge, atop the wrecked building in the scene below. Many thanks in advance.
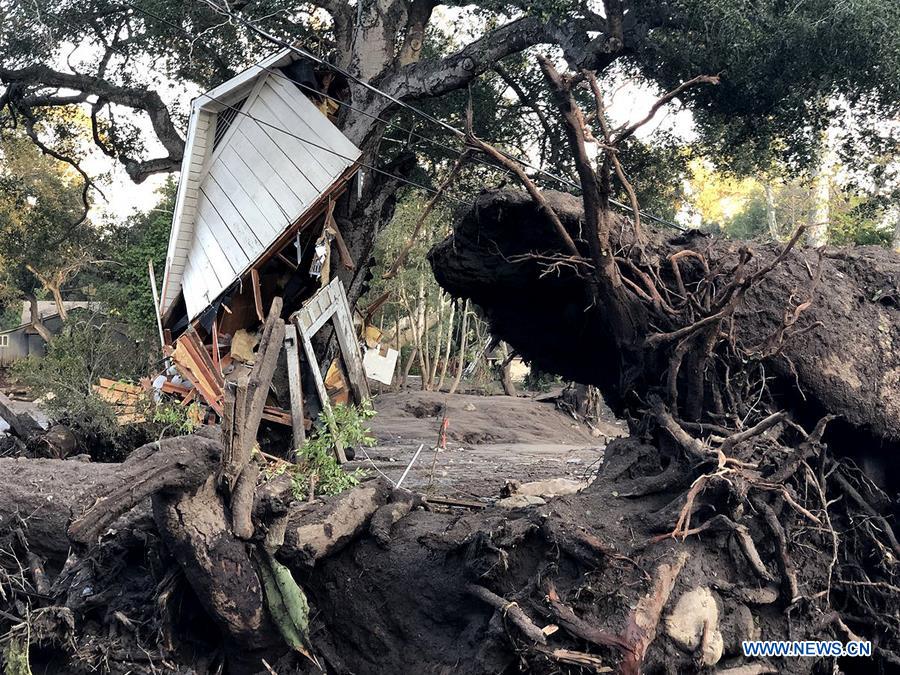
[161,49,360,320]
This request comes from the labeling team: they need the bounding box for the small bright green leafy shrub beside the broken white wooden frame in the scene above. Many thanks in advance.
[266,400,376,500]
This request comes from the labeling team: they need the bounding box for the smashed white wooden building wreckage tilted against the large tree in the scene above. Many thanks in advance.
[159,49,376,447]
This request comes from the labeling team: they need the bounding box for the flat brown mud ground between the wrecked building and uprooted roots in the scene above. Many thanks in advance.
[350,390,627,499]
